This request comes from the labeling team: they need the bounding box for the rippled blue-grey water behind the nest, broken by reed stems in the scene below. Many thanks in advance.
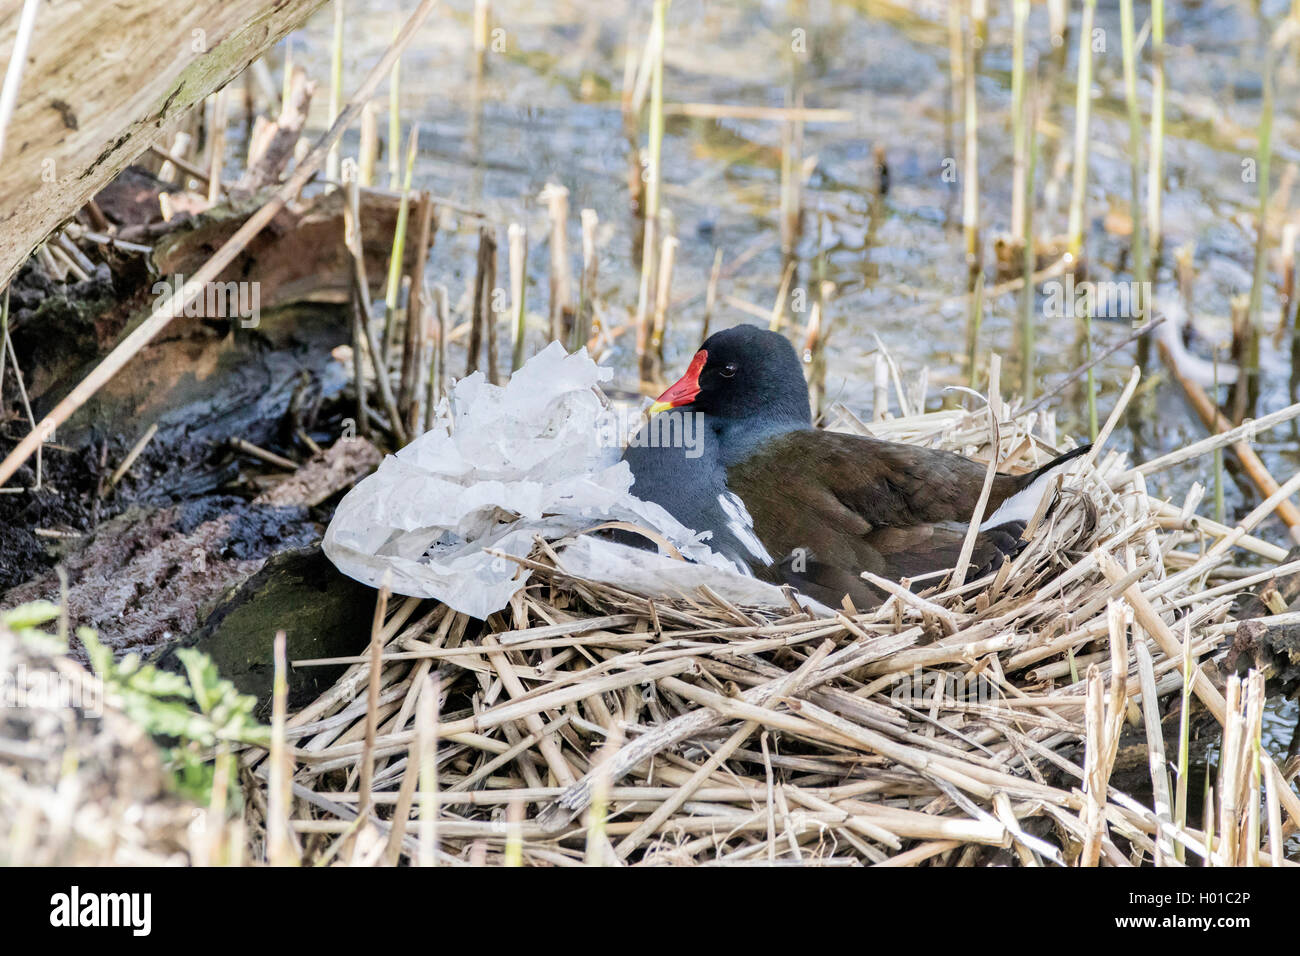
[293,0,1300,752]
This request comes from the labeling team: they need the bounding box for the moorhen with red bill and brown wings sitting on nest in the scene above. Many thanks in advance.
[623,325,1089,607]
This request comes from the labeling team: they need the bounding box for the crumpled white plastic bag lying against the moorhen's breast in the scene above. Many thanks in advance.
[321,342,788,618]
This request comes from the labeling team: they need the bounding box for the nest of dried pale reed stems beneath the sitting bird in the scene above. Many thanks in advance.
[243,376,1300,866]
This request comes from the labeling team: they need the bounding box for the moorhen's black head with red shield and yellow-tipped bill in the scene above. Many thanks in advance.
[650,325,813,425]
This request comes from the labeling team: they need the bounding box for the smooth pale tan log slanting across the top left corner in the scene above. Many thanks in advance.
[0,0,324,285]
